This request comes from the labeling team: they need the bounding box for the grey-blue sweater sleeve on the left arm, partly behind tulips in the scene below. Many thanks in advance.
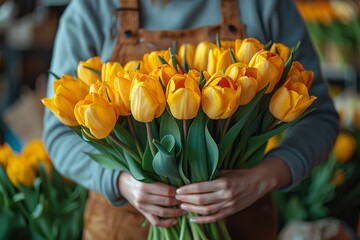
[43,0,124,205]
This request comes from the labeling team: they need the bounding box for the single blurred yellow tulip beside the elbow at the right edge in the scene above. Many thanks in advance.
[333,132,356,163]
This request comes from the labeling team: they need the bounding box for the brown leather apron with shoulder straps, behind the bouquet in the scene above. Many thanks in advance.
[83,0,276,240]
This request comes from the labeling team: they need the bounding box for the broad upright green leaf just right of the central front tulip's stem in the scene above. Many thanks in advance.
[186,109,210,182]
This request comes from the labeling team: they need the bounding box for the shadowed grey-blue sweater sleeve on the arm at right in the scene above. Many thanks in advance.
[264,0,339,191]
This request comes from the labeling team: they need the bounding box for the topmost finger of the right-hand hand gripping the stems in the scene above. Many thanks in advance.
[176,180,223,194]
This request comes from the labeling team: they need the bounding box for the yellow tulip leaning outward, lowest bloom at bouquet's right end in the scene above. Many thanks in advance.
[269,81,316,122]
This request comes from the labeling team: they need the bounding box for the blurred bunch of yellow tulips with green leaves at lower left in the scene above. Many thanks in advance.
[0,140,87,240]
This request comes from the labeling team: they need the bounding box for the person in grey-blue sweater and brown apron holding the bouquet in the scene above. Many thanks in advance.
[43,0,339,239]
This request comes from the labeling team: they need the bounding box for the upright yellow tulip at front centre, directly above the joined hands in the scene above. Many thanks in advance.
[166,74,201,119]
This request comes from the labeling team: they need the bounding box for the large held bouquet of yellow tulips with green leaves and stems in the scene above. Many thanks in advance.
[42,38,316,239]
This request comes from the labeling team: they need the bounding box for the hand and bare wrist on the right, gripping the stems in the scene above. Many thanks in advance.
[175,158,291,223]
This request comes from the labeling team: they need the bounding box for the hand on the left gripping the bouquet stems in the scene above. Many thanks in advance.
[118,172,184,227]
